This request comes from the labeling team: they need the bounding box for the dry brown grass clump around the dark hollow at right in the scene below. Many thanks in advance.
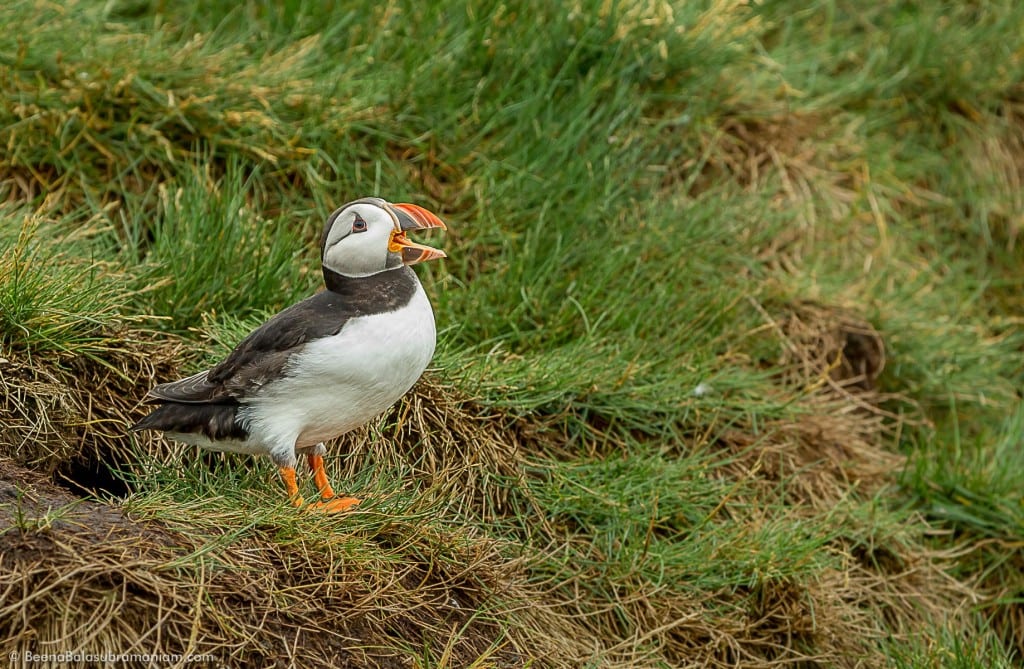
[723,301,908,504]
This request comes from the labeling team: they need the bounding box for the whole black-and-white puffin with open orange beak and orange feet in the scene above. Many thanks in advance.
[131,198,446,513]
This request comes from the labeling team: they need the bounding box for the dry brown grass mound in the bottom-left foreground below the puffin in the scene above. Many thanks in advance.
[0,459,565,667]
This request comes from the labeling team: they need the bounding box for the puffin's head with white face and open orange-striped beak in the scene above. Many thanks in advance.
[321,198,446,277]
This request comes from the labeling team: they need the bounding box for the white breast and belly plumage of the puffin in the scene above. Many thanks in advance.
[240,285,436,452]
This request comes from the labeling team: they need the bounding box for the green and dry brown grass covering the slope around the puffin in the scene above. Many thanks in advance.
[0,0,1024,667]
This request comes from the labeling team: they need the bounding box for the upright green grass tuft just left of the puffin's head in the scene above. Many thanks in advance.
[117,153,309,331]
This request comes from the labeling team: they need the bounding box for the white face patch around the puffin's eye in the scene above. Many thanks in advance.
[323,203,401,277]
